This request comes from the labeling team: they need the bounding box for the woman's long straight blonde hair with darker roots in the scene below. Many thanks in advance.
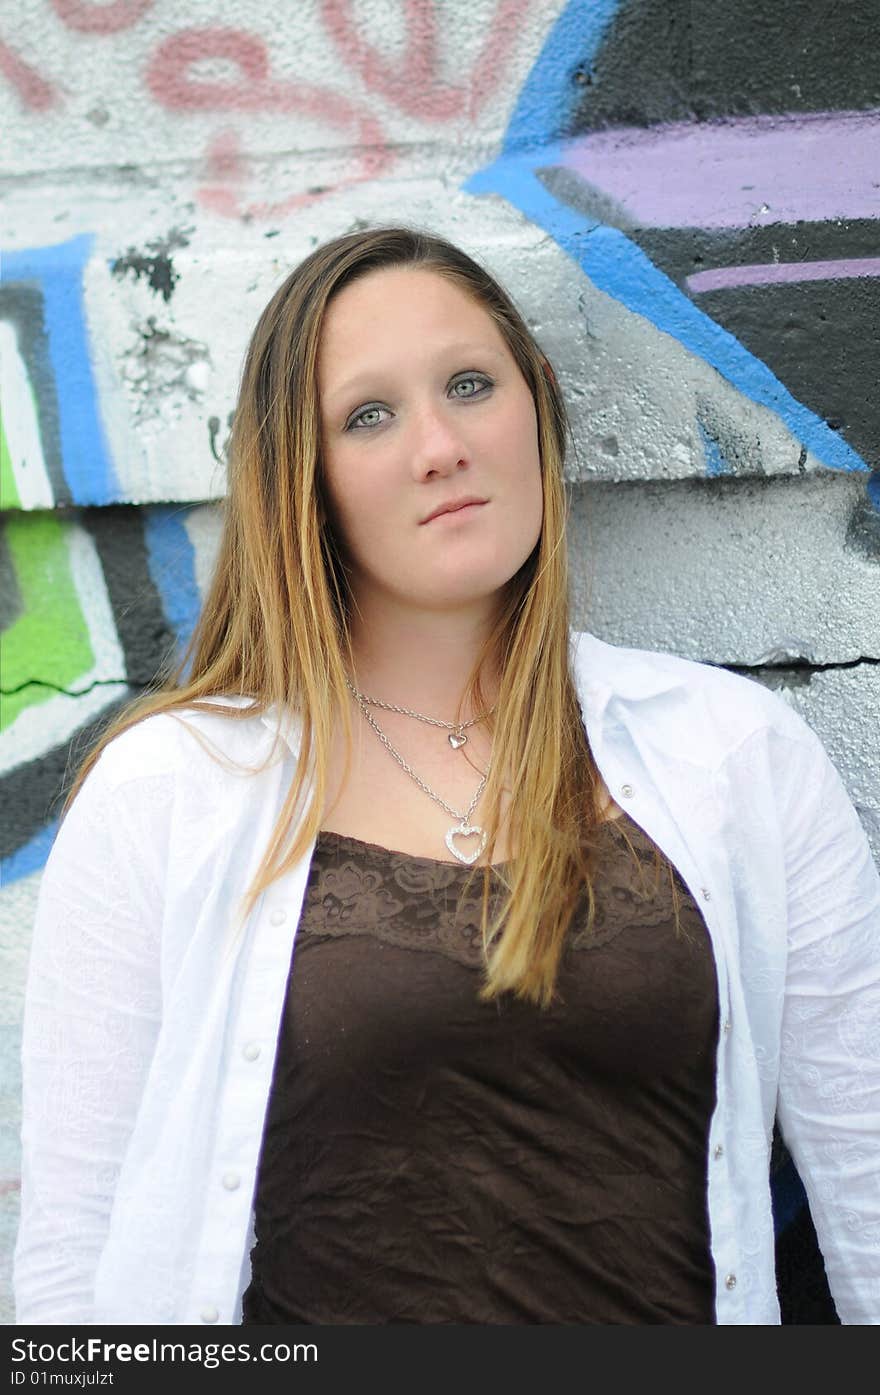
[66,227,674,1007]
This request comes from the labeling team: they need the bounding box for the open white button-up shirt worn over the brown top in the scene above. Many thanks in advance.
[15,635,880,1324]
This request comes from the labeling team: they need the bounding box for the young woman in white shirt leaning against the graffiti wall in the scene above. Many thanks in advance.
[15,229,880,1324]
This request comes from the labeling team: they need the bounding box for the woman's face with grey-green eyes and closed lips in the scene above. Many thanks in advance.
[318,266,543,612]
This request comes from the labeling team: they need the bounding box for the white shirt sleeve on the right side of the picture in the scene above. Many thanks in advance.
[777,727,880,1324]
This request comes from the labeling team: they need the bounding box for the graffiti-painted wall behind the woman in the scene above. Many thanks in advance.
[0,0,880,1322]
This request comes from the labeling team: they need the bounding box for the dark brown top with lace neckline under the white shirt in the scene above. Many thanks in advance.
[243,816,717,1324]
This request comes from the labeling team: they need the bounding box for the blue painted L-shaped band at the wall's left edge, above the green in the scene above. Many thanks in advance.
[3,233,120,505]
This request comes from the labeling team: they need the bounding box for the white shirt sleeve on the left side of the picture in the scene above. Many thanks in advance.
[14,747,170,1324]
